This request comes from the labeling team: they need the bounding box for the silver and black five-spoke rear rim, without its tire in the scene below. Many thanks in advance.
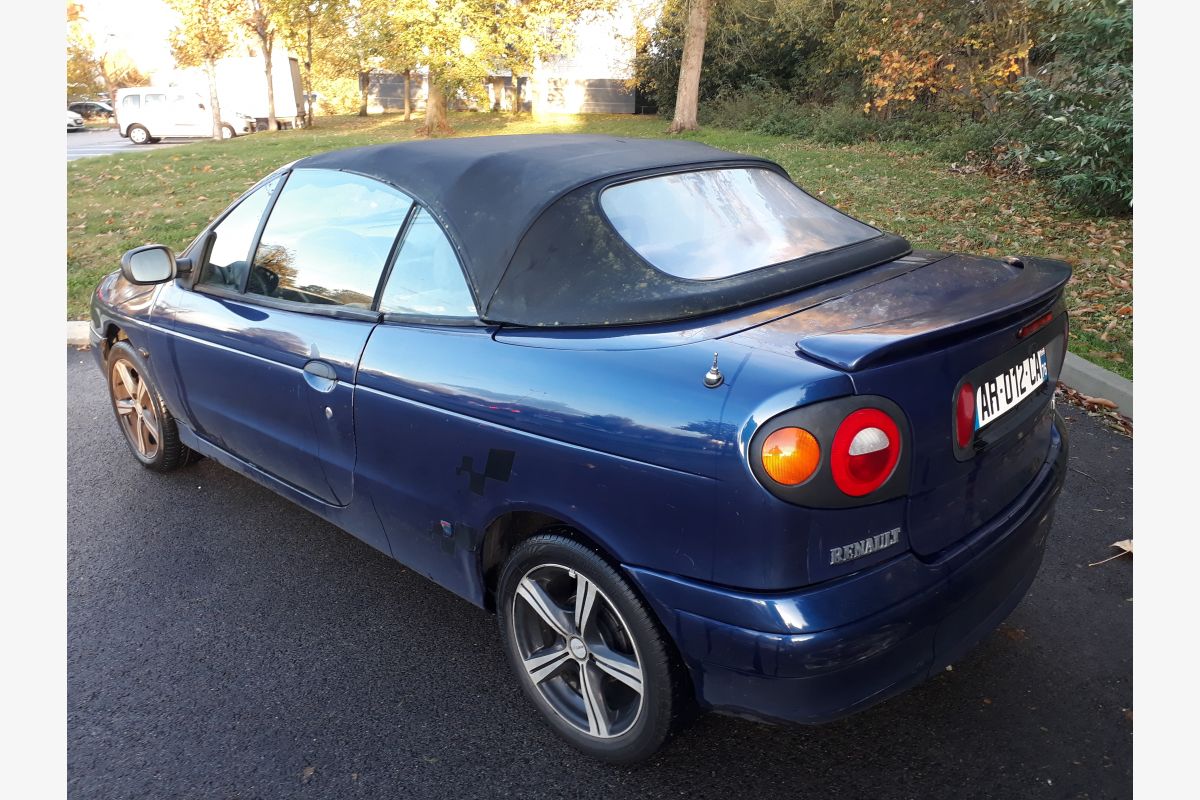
[510,564,643,739]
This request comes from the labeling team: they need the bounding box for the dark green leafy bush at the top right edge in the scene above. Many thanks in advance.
[1013,0,1133,213]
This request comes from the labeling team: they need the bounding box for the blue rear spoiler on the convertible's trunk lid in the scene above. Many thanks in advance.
[796,257,1070,372]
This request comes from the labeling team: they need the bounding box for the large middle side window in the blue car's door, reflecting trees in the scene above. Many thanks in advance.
[246,169,413,308]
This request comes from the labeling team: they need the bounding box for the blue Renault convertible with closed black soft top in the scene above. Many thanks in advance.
[91,136,1070,763]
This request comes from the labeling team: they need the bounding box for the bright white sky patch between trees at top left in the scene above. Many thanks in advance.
[82,0,175,73]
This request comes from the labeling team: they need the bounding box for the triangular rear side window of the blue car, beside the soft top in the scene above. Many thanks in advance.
[379,209,476,318]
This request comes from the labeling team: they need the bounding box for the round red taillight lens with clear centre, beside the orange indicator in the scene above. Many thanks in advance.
[829,408,900,498]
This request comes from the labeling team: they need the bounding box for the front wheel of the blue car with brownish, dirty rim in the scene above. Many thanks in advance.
[106,342,192,473]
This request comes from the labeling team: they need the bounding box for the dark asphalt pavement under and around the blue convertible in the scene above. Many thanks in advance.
[67,350,1133,800]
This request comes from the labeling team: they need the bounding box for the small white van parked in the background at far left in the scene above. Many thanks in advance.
[116,86,254,144]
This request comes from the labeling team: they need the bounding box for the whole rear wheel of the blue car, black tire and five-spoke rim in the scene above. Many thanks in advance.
[497,535,682,764]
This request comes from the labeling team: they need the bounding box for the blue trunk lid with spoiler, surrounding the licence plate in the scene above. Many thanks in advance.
[733,253,1070,557]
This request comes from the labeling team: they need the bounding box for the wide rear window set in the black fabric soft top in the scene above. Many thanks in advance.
[600,168,881,281]
